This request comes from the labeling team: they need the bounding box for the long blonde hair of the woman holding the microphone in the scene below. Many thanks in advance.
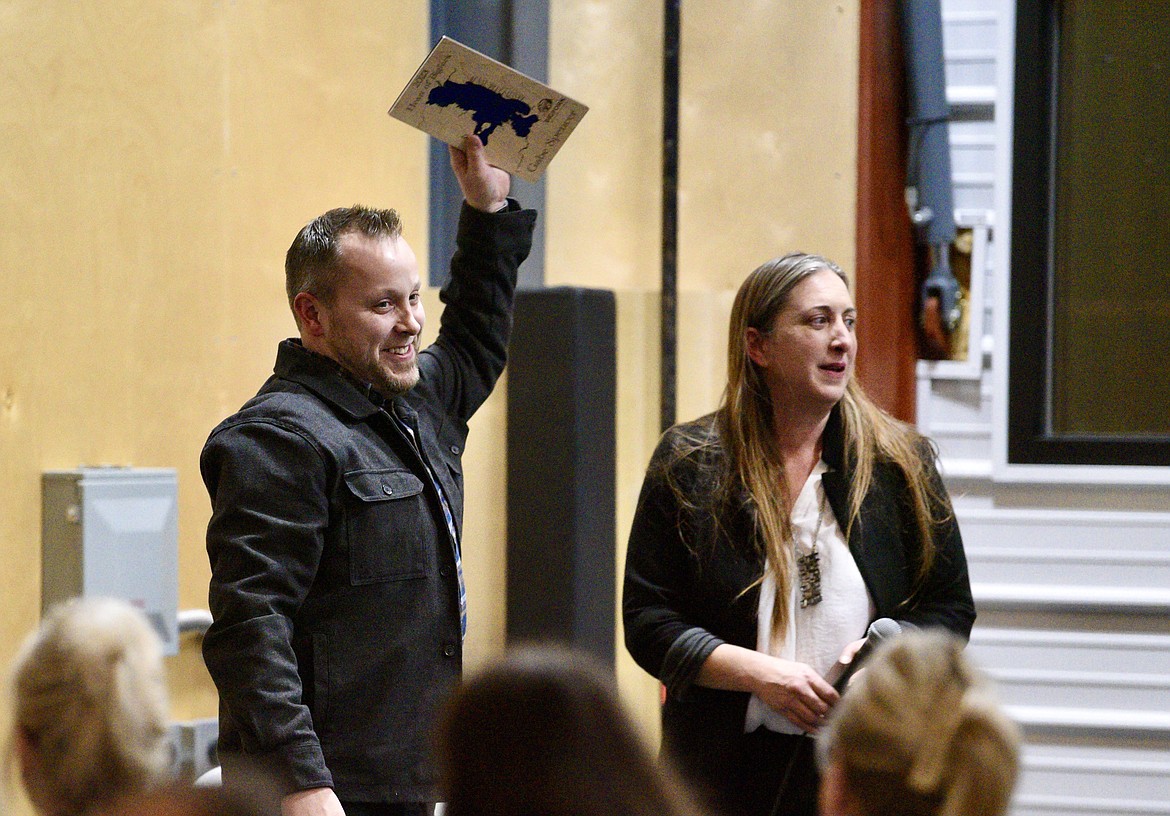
[679,252,949,633]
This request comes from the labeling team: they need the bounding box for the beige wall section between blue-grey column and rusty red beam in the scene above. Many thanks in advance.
[545,0,859,735]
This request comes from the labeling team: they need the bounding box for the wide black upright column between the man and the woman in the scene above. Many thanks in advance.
[508,287,617,666]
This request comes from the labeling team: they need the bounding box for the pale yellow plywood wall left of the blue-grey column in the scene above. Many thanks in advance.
[0,0,428,718]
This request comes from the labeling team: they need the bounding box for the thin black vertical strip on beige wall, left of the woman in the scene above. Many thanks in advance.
[659,0,681,431]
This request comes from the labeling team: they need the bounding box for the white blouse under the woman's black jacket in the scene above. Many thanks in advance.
[744,460,874,734]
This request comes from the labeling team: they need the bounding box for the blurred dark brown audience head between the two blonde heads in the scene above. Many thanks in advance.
[439,646,695,816]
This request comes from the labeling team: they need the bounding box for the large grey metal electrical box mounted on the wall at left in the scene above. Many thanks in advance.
[41,467,179,654]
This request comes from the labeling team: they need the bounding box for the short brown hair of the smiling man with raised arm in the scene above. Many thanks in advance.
[284,205,402,324]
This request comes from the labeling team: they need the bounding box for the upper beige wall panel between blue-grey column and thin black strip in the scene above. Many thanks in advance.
[545,0,662,289]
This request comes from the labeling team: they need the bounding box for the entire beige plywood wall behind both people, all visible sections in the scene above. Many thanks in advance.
[0,0,858,768]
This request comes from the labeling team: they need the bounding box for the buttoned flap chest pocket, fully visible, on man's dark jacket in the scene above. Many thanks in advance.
[345,471,434,584]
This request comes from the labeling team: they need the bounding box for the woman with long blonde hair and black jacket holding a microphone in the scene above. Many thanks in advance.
[622,253,975,816]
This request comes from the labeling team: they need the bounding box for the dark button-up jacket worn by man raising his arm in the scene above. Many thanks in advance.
[200,203,536,802]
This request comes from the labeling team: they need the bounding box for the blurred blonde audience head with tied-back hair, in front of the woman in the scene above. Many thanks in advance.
[817,631,1020,816]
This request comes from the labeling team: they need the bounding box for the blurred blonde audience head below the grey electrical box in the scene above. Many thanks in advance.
[5,598,171,816]
